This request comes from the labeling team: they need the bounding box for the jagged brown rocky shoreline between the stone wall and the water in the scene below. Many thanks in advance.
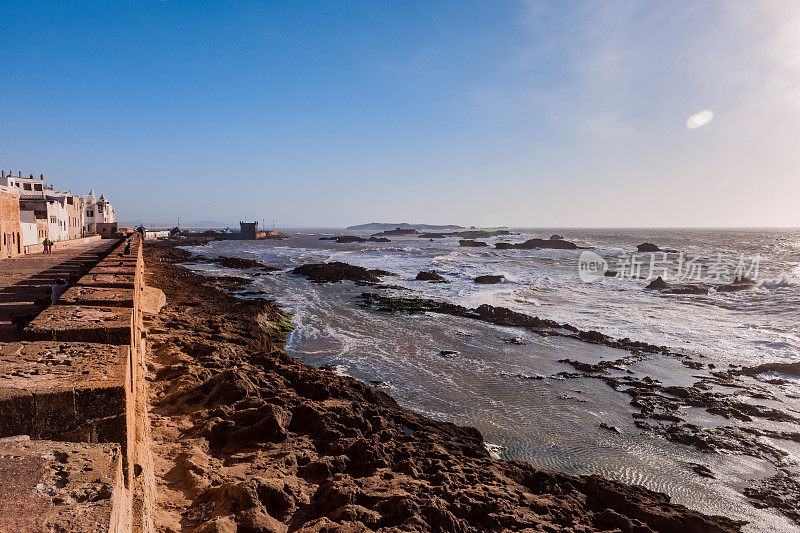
[145,243,742,532]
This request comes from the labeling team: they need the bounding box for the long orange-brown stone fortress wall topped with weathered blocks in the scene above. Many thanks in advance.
[0,234,158,532]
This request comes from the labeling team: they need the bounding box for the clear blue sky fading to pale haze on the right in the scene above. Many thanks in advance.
[0,0,800,227]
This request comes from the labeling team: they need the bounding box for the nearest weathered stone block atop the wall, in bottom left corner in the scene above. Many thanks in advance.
[0,437,123,533]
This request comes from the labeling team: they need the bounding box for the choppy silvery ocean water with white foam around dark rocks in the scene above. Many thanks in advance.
[187,228,800,531]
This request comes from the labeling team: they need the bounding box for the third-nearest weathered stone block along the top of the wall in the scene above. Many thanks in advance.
[21,305,133,345]
